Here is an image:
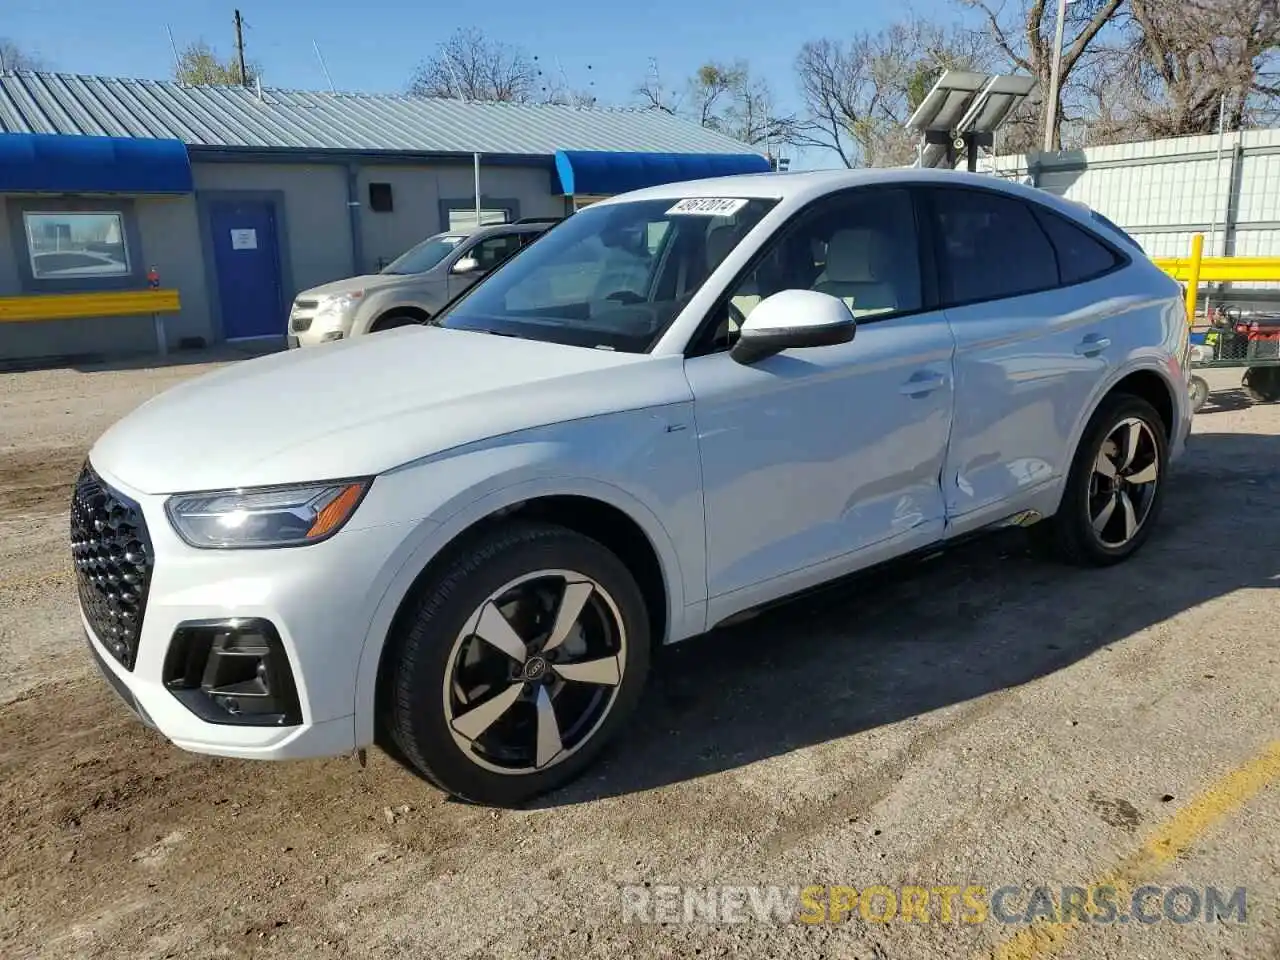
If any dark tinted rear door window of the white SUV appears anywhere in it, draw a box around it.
[933,189,1059,303]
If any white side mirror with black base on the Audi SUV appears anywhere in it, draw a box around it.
[730,291,858,364]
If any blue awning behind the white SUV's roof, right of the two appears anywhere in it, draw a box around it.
[556,150,771,197]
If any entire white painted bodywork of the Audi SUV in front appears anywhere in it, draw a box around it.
[74,170,1190,759]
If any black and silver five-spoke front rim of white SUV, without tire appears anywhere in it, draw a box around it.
[443,570,627,774]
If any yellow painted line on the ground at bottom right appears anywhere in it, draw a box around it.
[979,740,1280,960]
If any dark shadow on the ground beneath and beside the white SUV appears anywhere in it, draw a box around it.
[531,434,1280,808]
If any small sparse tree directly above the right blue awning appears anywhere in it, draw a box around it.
[636,60,796,146]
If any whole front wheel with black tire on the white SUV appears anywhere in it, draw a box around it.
[383,522,650,806]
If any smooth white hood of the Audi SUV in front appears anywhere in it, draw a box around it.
[90,326,689,494]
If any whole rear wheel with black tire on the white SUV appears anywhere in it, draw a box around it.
[1030,393,1169,567]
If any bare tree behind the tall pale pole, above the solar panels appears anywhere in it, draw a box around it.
[957,0,1126,150]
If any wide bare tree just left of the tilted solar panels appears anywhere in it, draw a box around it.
[794,17,987,166]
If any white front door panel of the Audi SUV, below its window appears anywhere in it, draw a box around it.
[685,305,952,617]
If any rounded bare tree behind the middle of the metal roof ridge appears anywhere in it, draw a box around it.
[410,27,539,104]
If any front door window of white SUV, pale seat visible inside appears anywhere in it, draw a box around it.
[708,188,923,349]
